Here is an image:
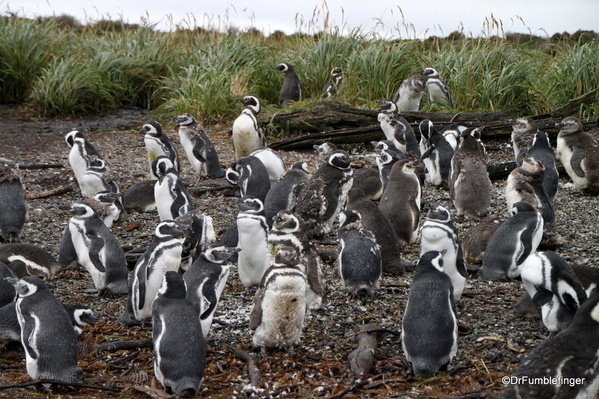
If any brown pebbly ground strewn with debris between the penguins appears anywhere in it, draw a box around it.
[0,107,599,398]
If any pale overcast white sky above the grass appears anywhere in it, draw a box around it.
[0,0,599,38]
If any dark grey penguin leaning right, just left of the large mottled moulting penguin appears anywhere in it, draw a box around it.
[264,161,310,227]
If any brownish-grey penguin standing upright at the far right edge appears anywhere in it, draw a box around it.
[556,116,599,194]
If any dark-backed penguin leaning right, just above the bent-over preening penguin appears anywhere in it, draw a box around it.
[478,201,543,280]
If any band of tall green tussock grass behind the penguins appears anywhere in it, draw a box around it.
[0,16,599,122]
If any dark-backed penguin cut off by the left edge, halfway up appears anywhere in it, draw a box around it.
[0,159,29,242]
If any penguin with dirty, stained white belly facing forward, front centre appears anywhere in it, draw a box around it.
[250,247,306,354]
